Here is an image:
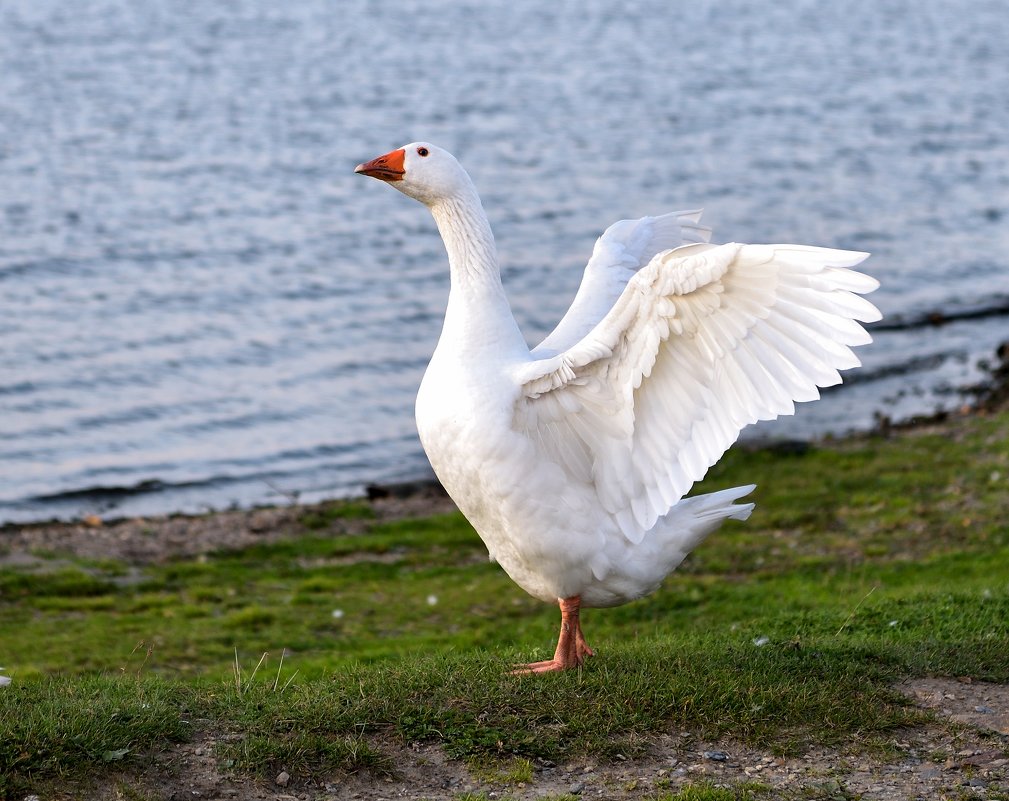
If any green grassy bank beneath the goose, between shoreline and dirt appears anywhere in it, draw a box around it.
[0,414,1009,799]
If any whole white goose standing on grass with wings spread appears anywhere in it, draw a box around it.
[355,142,880,673]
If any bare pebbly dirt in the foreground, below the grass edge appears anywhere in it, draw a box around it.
[101,679,1009,801]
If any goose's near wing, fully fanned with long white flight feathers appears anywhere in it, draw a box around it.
[515,243,880,542]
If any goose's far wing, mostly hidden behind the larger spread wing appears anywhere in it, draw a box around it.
[533,210,711,359]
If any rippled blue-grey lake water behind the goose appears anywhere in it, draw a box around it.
[0,0,1009,521]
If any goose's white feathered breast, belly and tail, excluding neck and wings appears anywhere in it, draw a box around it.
[417,348,753,606]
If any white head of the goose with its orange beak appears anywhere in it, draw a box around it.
[354,142,472,206]
